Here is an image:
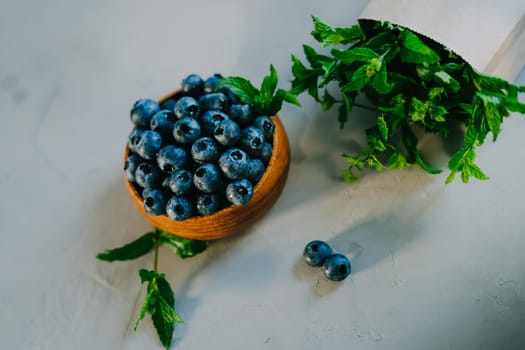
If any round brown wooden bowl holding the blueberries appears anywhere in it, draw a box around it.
[124,90,290,240]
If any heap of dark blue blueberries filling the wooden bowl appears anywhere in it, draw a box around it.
[124,74,275,221]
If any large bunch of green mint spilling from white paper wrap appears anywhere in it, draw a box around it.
[291,17,525,183]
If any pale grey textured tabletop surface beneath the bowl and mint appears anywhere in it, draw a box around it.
[0,0,525,350]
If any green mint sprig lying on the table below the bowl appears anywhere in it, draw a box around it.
[97,228,208,349]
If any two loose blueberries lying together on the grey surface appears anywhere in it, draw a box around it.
[303,240,352,281]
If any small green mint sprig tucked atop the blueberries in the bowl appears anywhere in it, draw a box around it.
[216,65,301,116]
